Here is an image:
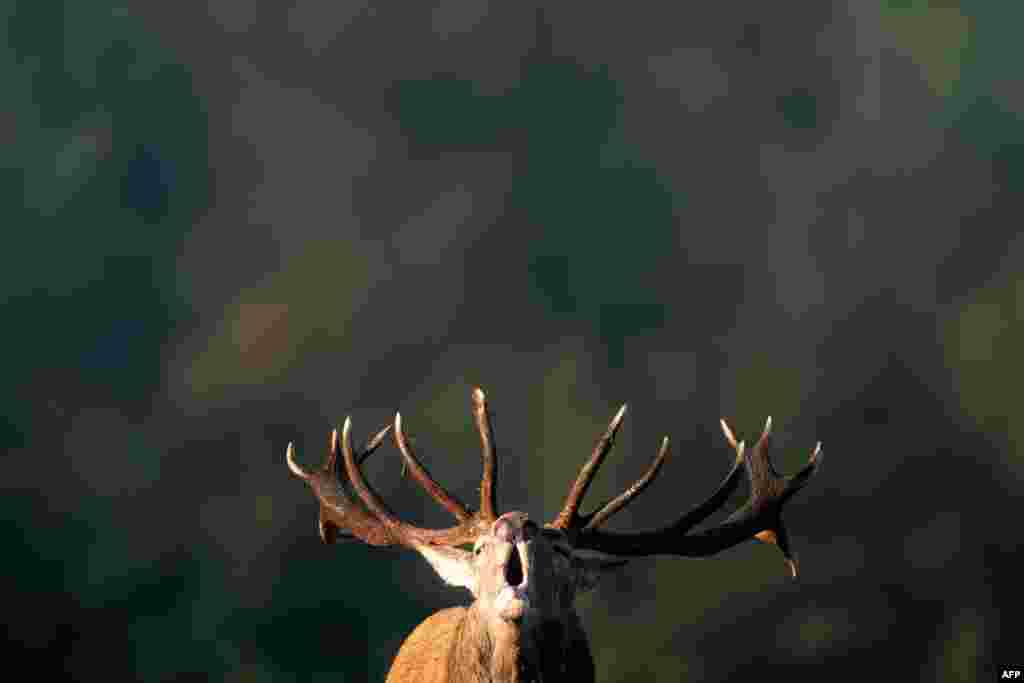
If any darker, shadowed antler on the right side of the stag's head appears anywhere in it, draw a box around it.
[550,405,821,578]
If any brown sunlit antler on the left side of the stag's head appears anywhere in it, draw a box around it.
[287,388,498,547]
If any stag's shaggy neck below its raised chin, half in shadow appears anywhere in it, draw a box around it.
[450,607,594,683]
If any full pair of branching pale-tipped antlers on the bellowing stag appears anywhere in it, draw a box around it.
[287,388,821,577]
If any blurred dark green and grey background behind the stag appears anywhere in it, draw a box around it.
[0,0,1024,681]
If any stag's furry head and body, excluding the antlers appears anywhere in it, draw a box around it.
[387,512,601,683]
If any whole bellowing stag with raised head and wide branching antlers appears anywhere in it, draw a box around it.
[287,388,821,683]
